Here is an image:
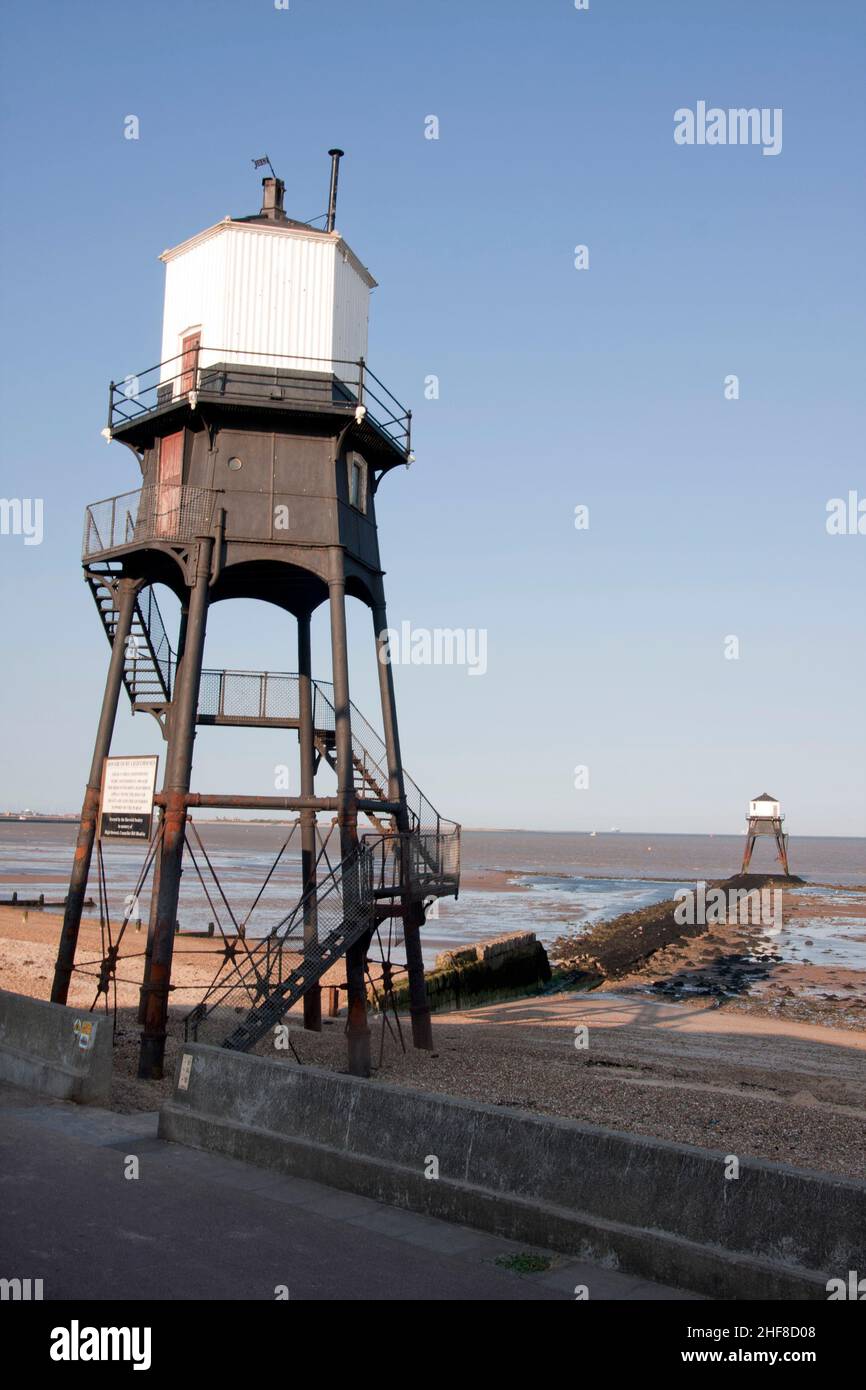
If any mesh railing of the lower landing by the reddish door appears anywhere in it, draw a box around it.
[82,484,215,560]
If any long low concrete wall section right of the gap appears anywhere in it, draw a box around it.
[160,1044,866,1300]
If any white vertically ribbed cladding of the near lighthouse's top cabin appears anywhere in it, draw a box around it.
[163,224,370,375]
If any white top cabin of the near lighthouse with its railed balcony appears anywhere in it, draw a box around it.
[106,173,411,468]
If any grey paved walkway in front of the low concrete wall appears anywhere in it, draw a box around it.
[0,1086,691,1301]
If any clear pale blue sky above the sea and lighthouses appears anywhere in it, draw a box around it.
[0,0,866,834]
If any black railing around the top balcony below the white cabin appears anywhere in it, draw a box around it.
[108,345,411,456]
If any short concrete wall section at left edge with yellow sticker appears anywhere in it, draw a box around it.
[0,990,113,1105]
